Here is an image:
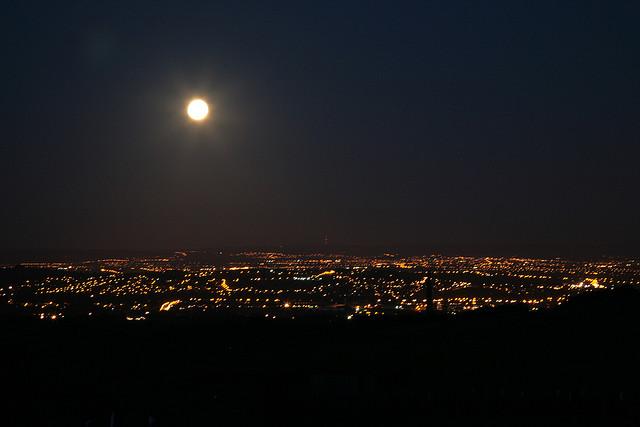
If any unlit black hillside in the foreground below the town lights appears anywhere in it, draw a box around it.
[0,290,640,426]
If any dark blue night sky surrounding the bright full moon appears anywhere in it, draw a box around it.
[0,0,640,256]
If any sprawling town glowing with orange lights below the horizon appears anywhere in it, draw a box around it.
[0,252,640,321]
